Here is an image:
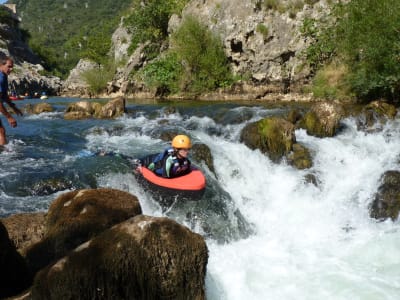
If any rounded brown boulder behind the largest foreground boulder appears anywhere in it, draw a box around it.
[26,188,142,272]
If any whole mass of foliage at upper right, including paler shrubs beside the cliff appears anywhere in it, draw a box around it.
[303,0,400,100]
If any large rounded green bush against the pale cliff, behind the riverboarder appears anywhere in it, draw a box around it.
[142,16,233,94]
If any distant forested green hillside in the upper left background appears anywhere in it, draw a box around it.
[8,0,132,77]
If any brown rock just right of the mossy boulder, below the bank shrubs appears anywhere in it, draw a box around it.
[299,102,345,138]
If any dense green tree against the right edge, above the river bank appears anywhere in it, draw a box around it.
[336,0,400,100]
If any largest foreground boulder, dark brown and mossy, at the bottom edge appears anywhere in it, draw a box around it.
[32,215,208,300]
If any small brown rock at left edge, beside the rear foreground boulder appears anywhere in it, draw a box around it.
[0,212,46,255]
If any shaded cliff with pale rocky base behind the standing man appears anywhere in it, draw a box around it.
[0,8,61,95]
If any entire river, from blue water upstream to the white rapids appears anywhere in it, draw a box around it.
[0,98,400,300]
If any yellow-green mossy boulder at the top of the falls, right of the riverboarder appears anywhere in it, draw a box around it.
[240,117,296,162]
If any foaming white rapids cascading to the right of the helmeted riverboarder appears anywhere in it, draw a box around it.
[203,120,400,300]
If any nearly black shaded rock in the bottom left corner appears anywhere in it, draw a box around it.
[0,222,32,299]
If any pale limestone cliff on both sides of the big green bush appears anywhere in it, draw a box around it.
[65,0,336,98]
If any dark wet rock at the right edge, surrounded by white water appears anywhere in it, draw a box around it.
[370,171,400,221]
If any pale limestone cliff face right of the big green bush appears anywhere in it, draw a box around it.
[180,0,329,92]
